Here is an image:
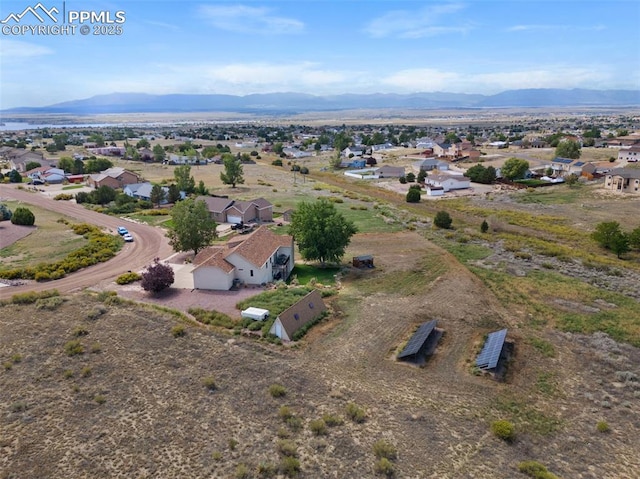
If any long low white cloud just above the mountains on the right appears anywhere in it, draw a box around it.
[381,66,613,94]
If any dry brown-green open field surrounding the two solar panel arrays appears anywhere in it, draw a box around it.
[0,148,640,479]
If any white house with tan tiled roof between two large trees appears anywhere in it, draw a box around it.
[192,226,294,290]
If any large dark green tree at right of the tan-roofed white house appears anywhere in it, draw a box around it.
[289,198,357,264]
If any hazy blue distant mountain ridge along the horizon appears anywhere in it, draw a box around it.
[1,88,640,115]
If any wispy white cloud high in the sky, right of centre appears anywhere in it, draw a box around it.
[364,3,471,38]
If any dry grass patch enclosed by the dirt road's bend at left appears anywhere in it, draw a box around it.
[0,201,88,270]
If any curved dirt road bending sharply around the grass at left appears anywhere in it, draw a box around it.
[0,185,173,299]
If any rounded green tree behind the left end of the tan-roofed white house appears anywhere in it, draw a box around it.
[167,198,217,255]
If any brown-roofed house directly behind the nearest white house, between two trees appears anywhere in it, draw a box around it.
[198,196,273,224]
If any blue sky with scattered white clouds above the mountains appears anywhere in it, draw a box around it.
[0,0,640,109]
